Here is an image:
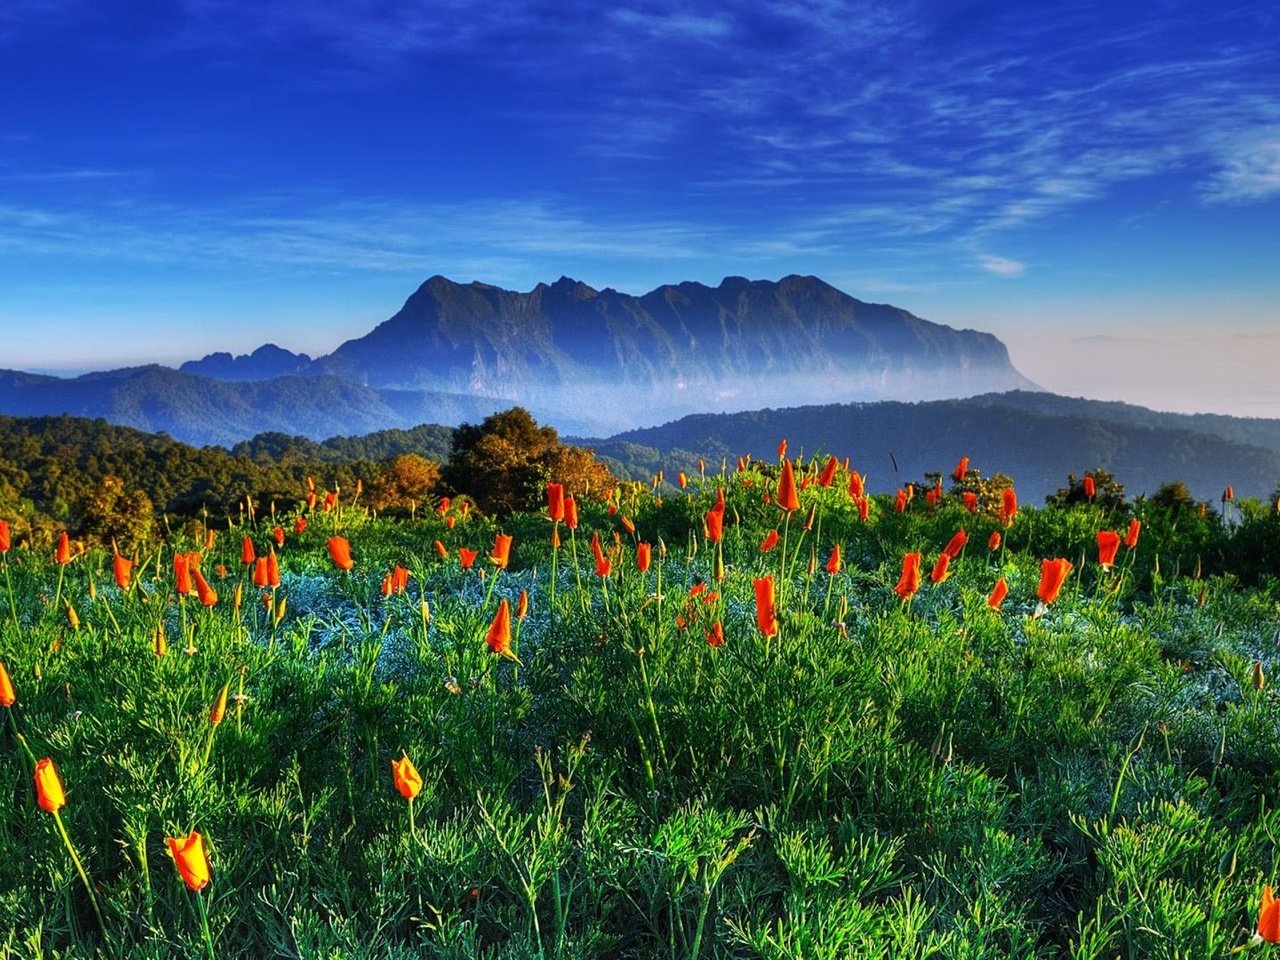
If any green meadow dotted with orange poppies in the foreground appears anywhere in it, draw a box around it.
[0,456,1280,960]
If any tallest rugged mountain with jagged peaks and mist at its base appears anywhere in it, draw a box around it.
[314,276,1036,430]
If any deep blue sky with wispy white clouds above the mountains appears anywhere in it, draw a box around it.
[0,0,1280,416]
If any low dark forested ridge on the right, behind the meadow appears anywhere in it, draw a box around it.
[583,393,1280,500]
